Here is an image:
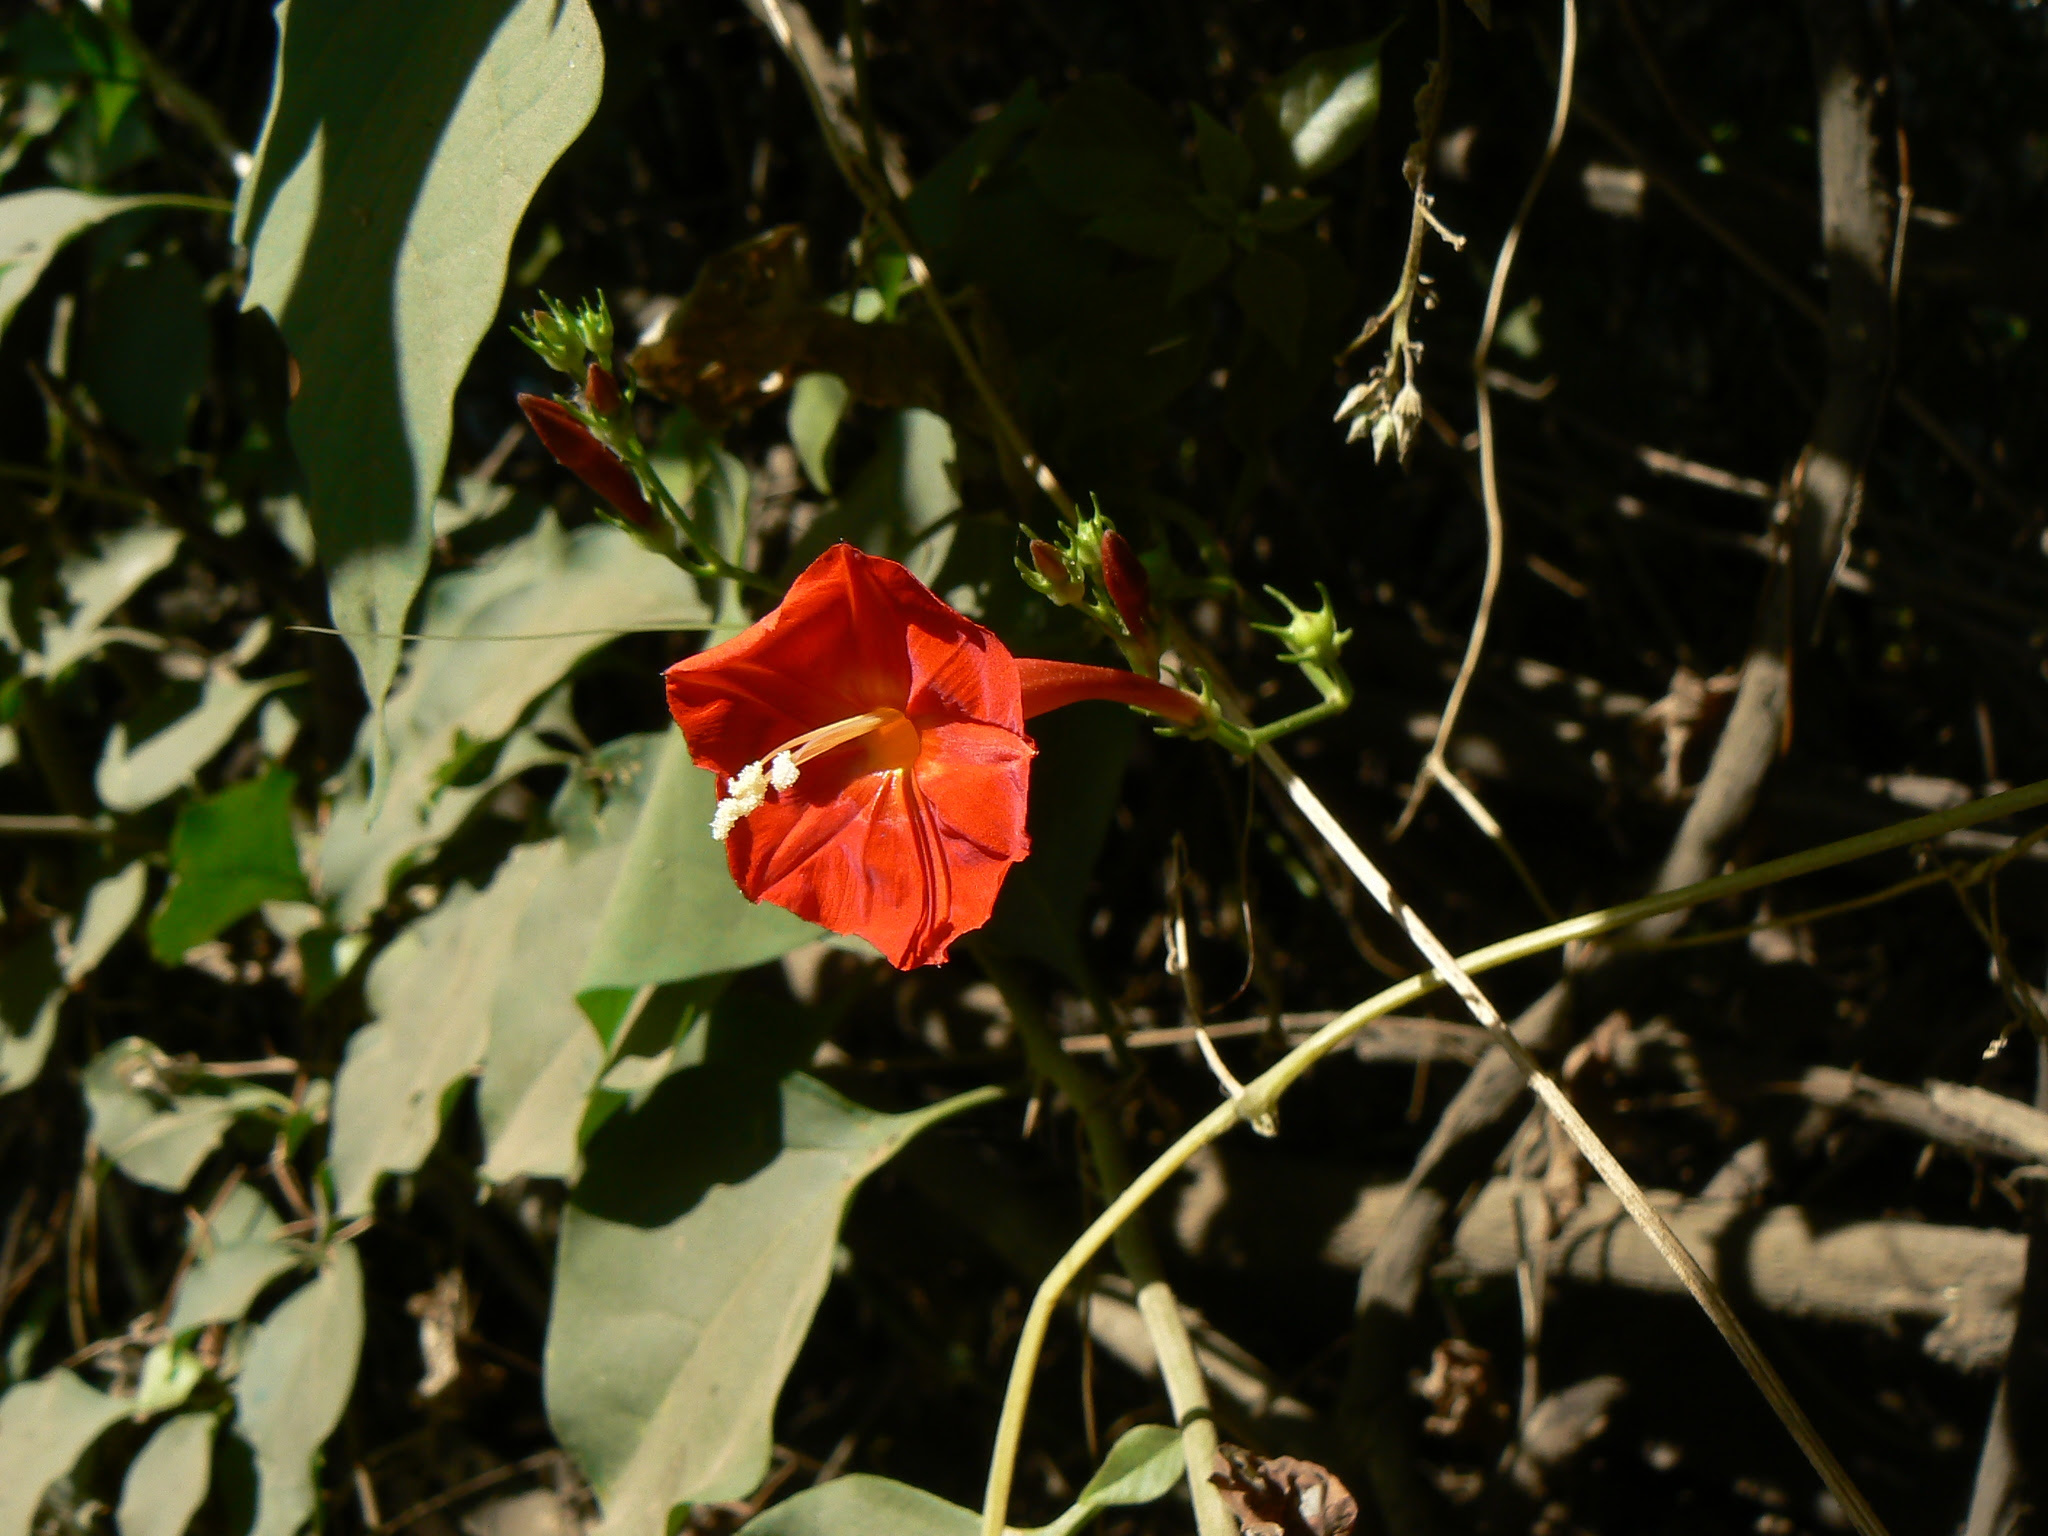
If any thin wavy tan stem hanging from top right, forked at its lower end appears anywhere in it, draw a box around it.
[1389,0,1579,856]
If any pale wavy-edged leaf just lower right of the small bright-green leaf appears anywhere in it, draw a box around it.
[328,858,567,1217]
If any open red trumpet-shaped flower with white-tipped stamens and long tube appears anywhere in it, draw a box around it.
[666,545,1202,969]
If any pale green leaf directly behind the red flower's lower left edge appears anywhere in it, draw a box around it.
[575,731,823,1020]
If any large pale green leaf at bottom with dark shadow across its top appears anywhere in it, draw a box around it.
[545,1073,989,1532]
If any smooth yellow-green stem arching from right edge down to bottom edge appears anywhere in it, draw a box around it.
[981,764,2048,1536]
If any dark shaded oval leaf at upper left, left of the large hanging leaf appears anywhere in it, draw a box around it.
[74,256,213,459]
